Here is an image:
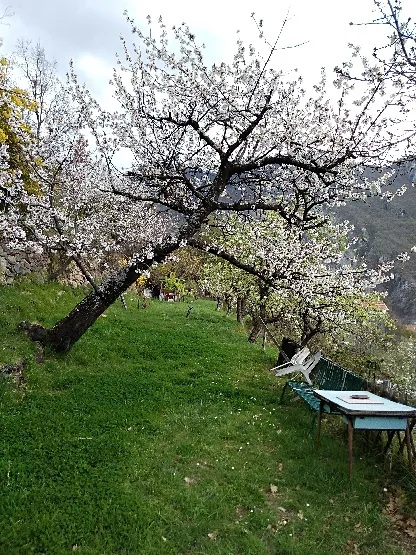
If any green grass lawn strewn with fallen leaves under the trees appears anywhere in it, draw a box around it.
[0,282,410,555]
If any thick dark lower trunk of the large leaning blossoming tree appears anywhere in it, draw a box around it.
[20,242,179,352]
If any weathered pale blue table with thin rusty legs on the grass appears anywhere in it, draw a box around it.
[313,389,416,478]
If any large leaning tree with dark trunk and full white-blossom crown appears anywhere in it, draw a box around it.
[4,17,412,351]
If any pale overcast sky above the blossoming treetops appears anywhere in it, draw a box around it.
[0,0,402,88]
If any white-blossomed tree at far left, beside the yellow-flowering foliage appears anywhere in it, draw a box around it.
[3,43,173,291]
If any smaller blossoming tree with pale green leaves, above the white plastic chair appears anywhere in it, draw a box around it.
[198,213,391,346]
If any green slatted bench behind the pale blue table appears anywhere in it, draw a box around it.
[280,356,367,433]
